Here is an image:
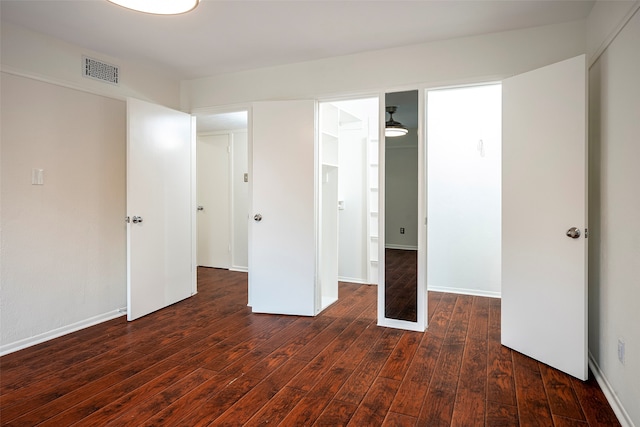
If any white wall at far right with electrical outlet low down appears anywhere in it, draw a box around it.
[589,3,640,426]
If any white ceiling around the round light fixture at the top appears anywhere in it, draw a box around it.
[0,0,594,79]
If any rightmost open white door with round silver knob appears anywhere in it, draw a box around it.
[502,55,587,380]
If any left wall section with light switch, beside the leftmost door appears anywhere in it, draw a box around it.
[0,73,126,353]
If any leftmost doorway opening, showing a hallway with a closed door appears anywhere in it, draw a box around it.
[196,111,249,271]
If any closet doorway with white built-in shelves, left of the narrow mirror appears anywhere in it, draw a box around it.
[319,97,379,290]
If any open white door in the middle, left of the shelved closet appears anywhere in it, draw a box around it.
[249,100,316,315]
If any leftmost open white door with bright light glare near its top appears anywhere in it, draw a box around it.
[127,99,196,320]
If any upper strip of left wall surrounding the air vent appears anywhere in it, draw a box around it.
[0,22,180,109]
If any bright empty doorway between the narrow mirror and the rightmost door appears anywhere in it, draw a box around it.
[426,84,502,297]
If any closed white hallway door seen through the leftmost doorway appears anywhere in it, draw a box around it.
[196,134,231,268]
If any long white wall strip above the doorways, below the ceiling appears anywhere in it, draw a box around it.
[182,21,585,111]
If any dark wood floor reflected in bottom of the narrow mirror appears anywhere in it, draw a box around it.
[384,249,418,322]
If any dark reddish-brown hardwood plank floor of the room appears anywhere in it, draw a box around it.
[0,269,619,427]
